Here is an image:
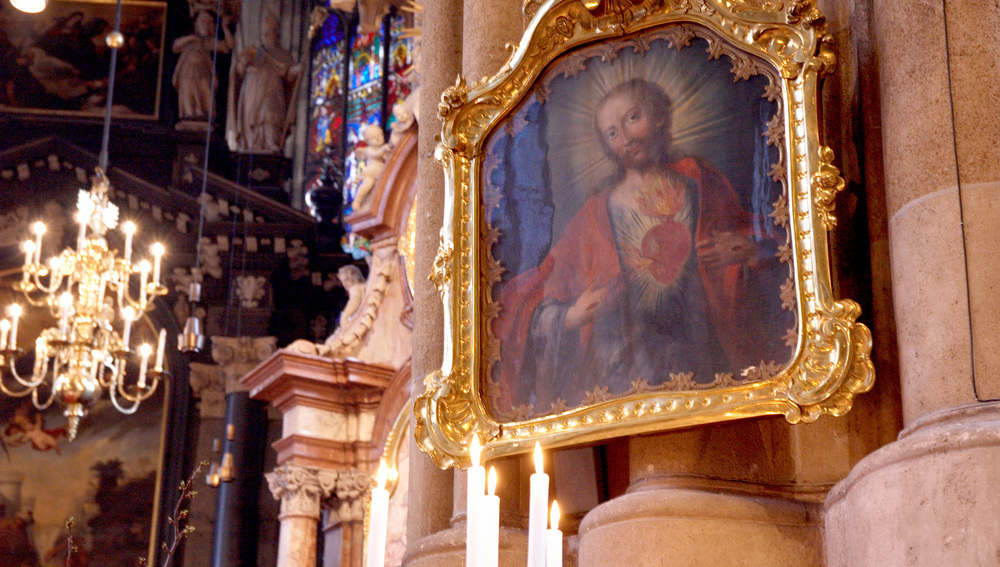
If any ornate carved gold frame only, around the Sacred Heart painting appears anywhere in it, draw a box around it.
[414,0,874,468]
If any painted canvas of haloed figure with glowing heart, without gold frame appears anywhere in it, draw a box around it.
[484,27,795,419]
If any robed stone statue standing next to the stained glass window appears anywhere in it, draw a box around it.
[226,13,302,154]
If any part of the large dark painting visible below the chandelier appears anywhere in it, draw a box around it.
[0,386,166,567]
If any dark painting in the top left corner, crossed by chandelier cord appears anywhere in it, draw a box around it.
[0,0,167,120]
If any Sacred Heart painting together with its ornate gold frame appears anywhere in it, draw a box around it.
[414,0,874,466]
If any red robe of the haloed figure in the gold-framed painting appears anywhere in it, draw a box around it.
[493,158,757,414]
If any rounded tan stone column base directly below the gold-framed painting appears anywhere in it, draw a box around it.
[579,488,823,567]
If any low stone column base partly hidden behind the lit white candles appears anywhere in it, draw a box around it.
[403,522,528,567]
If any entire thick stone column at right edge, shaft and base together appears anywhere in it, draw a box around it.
[825,0,1000,567]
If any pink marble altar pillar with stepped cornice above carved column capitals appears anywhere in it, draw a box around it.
[241,350,396,567]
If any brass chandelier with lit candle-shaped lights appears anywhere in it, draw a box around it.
[0,168,167,441]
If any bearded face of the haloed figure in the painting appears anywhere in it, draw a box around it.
[597,90,665,170]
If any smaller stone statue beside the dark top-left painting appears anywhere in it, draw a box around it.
[173,10,233,121]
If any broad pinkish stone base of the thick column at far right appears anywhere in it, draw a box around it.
[825,404,1000,567]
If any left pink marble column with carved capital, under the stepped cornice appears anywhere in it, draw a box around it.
[265,463,337,567]
